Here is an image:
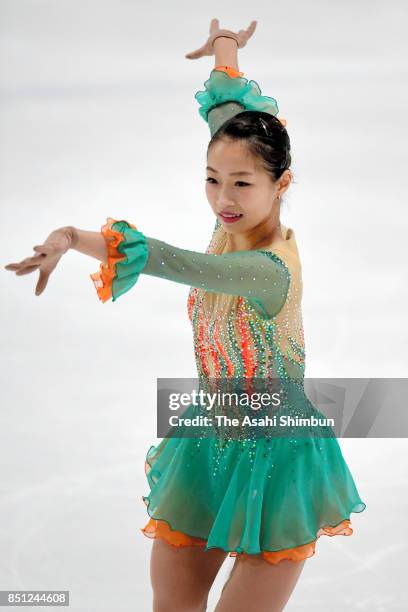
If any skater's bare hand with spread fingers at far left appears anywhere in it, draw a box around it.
[4,227,75,295]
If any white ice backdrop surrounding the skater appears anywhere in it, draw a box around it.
[0,0,408,612]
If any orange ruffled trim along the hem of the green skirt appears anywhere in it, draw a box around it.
[140,517,353,565]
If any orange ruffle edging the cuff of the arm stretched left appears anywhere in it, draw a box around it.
[90,217,137,302]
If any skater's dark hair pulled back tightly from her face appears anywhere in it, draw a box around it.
[207,110,292,181]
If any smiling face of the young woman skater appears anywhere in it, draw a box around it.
[205,138,290,233]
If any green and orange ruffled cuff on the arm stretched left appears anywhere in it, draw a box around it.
[90,217,149,302]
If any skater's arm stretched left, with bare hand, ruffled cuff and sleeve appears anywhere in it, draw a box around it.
[5,217,291,318]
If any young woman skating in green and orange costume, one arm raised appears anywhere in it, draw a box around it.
[6,19,365,612]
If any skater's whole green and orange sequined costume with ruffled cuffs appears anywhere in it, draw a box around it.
[91,66,366,564]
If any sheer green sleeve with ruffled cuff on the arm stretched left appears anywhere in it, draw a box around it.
[91,217,291,318]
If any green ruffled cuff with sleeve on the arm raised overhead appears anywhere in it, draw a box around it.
[194,66,286,136]
